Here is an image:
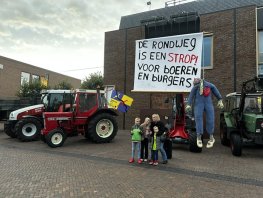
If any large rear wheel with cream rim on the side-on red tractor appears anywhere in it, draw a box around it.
[85,113,118,143]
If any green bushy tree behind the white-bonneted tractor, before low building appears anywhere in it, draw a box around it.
[16,81,48,97]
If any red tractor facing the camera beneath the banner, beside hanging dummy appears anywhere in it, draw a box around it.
[164,93,202,159]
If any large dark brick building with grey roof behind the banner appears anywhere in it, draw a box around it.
[104,0,263,129]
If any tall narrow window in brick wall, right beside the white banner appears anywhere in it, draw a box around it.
[202,35,213,69]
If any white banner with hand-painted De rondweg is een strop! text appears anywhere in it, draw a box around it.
[133,33,203,92]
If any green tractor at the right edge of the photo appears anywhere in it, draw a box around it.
[220,77,263,156]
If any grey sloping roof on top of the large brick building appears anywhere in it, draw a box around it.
[119,0,263,29]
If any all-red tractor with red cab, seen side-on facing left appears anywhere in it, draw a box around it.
[41,90,118,148]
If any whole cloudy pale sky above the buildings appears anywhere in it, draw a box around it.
[0,0,172,80]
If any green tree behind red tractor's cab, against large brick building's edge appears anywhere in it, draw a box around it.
[80,72,104,89]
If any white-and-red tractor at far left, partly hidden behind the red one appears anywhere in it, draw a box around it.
[4,90,71,141]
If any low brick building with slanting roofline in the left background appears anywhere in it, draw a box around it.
[0,56,81,99]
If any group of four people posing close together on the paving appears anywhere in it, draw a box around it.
[129,114,168,166]
